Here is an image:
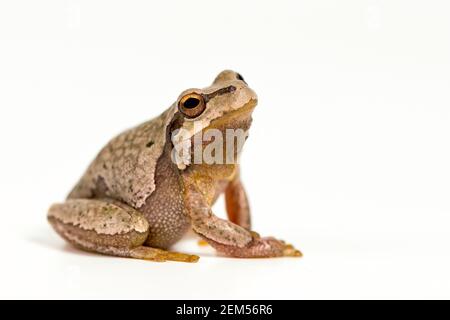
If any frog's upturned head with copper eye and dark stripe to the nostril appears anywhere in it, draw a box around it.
[171,70,257,169]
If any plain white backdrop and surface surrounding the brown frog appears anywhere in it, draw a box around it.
[0,0,450,299]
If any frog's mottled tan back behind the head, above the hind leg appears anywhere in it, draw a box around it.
[68,107,174,208]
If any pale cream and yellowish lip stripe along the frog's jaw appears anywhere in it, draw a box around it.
[171,99,258,170]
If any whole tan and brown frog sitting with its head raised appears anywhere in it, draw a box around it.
[47,70,302,262]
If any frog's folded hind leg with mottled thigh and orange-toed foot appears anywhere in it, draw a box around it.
[48,199,198,262]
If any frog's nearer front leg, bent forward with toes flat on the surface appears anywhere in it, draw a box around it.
[185,184,301,258]
